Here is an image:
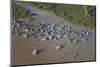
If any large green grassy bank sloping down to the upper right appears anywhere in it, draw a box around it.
[24,2,96,28]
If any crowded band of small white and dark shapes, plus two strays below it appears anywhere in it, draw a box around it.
[11,20,90,55]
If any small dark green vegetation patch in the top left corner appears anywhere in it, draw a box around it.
[12,3,28,19]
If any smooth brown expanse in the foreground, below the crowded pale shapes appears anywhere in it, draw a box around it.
[11,31,95,65]
